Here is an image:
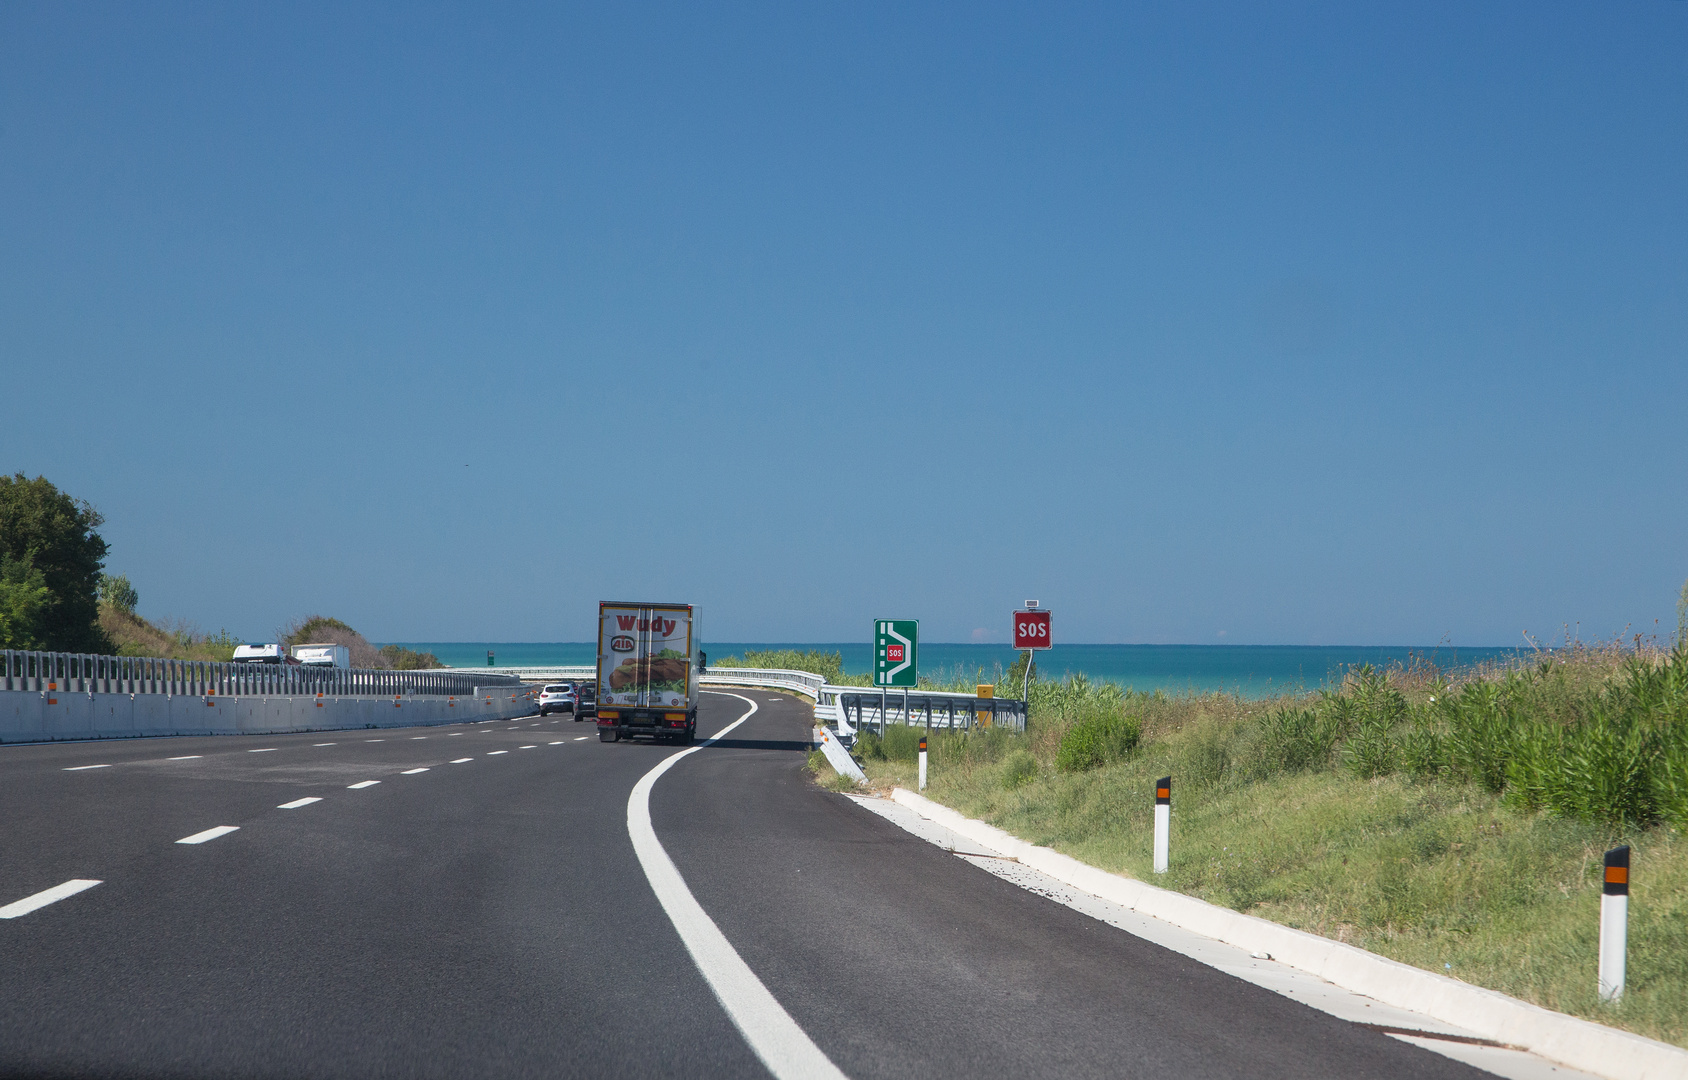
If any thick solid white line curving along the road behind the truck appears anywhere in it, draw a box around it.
[628,690,844,1080]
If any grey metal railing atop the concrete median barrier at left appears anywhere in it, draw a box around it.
[0,650,522,697]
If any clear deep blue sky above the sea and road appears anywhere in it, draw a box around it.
[0,0,1688,645]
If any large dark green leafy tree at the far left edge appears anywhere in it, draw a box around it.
[0,473,111,653]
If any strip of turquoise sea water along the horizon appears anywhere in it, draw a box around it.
[397,641,1518,697]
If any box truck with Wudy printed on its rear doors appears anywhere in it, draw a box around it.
[598,601,704,743]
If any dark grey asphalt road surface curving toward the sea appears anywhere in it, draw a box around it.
[0,690,1505,1080]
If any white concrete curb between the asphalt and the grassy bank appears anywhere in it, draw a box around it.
[891,788,1688,1080]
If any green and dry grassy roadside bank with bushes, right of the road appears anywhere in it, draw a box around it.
[850,637,1688,1046]
